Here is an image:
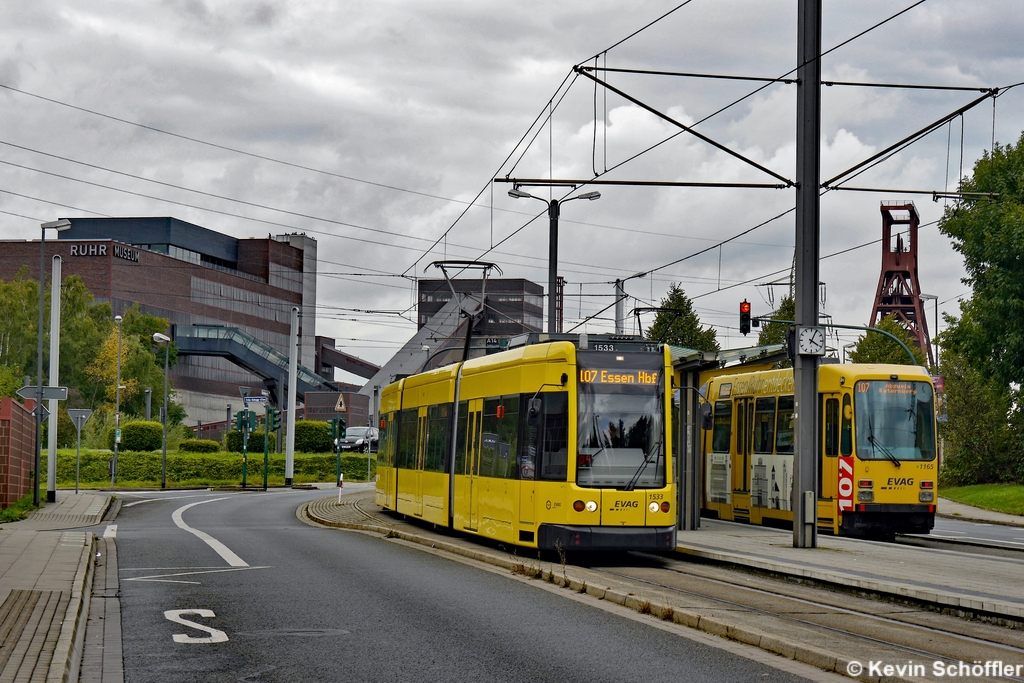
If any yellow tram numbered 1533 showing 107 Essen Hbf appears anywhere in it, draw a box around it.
[376,341,676,551]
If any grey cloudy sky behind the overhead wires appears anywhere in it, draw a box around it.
[0,0,1024,382]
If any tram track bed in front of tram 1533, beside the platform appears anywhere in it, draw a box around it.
[587,559,1024,681]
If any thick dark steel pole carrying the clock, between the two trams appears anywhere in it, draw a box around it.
[793,0,821,548]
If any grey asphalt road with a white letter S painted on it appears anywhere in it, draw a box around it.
[110,490,817,683]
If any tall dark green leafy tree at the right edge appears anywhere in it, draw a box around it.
[939,133,1024,395]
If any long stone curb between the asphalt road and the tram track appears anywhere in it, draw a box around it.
[295,501,914,683]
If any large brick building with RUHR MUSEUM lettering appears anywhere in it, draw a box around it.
[0,217,316,424]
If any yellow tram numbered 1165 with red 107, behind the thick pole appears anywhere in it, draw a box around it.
[702,365,938,538]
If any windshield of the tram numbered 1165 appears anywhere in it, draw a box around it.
[854,380,935,466]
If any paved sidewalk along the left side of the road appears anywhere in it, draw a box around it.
[0,490,111,683]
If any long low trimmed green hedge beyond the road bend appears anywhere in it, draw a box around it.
[40,450,376,487]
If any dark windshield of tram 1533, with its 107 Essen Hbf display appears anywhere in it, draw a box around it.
[577,352,667,489]
